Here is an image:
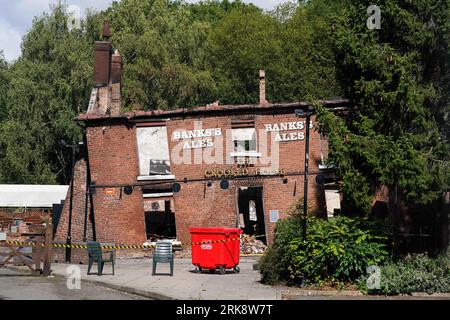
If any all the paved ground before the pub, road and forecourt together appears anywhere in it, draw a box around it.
[4,257,450,300]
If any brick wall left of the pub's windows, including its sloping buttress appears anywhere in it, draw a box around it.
[55,125,146,248]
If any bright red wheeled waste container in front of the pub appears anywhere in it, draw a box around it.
[189,228,242,274]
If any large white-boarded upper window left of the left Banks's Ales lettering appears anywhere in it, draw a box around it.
[136,126,171,176]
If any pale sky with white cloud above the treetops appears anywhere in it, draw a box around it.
[0,0,284,62]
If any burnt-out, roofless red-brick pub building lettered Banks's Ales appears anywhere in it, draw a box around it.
[55,25,348,252]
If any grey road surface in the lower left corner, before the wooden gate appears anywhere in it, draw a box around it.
[0,268,149,300]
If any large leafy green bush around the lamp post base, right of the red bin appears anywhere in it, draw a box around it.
[258,215,388,285]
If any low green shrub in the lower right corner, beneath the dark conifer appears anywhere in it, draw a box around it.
[359,254,450,295]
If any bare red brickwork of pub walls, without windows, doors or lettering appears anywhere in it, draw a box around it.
[57,110,324,244]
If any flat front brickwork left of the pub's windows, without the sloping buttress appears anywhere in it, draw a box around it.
[87,124,146,243]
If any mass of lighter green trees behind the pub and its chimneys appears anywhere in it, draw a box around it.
[0,0,384,183]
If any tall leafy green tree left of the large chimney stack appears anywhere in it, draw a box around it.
[0,4,92,183]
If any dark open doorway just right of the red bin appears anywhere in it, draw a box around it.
[238,187,267,244]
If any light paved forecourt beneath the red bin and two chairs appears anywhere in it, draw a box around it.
[47,257,282,300]
